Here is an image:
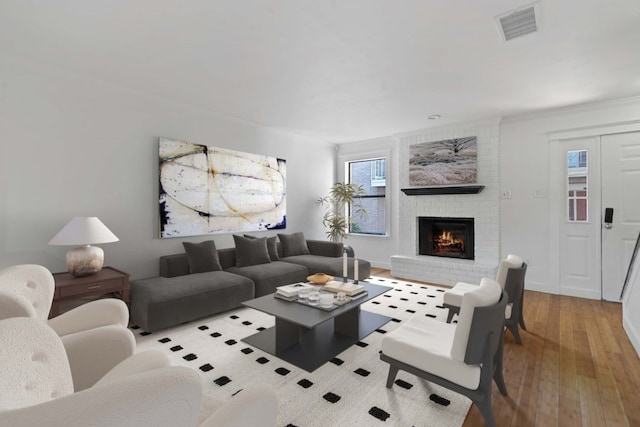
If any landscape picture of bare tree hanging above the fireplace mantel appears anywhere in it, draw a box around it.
[409,136,478,187]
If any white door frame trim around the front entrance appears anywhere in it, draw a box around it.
[547,120,640,299]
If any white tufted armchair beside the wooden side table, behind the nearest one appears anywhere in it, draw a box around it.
[0,264,135,390]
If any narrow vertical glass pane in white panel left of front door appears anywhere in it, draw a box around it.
[567,150,589,222]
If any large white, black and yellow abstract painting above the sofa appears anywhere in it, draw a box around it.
[159,138,286,238]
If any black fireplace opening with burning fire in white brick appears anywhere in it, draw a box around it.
[418,216,475,259]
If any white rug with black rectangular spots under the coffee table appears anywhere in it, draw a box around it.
[131,276,471,427]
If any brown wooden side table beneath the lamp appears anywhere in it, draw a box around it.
[49,267,130,318]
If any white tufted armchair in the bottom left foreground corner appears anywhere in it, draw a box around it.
[0,317,278,427]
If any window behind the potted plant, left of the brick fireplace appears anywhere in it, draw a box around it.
[345,158,387,236]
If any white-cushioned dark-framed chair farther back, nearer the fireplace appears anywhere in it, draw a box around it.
[442,254,527,344]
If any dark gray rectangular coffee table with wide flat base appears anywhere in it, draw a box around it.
[242,282,393,372]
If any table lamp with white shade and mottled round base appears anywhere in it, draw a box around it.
[49,216,119,277]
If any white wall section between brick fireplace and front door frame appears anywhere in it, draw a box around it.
[500,98,640,293]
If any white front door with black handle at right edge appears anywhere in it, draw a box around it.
[601,132,640,301]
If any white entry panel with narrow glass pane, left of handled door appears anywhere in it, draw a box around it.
[554,137,601,299]
